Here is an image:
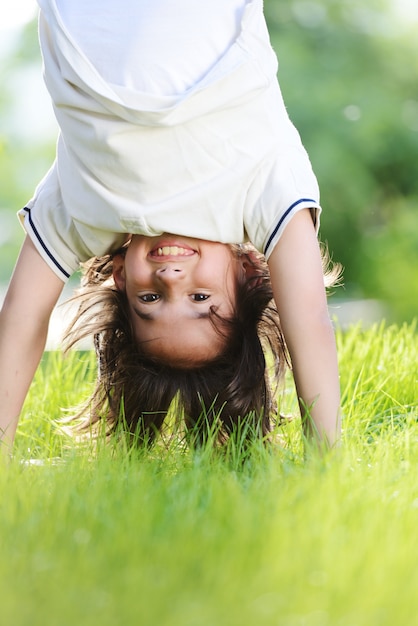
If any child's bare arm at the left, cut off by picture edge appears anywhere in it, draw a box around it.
[0,237,64,455]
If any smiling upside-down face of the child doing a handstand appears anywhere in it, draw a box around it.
[114,235,244,366]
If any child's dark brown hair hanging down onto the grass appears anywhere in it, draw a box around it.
[64,244,340,444]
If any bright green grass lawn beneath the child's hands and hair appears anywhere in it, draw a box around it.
[0,325,418,626]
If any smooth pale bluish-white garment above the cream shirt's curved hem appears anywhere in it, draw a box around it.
[56,0,247,95]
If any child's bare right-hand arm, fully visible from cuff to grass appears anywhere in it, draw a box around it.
[268,209,340,447]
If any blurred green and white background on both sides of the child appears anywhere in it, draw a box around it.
[0,0,418,321]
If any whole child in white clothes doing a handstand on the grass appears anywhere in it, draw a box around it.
[0,0,339,445]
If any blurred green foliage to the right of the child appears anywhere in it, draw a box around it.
[265,0,418,318]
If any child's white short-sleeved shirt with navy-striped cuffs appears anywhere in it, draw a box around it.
[19,0,320,280]
